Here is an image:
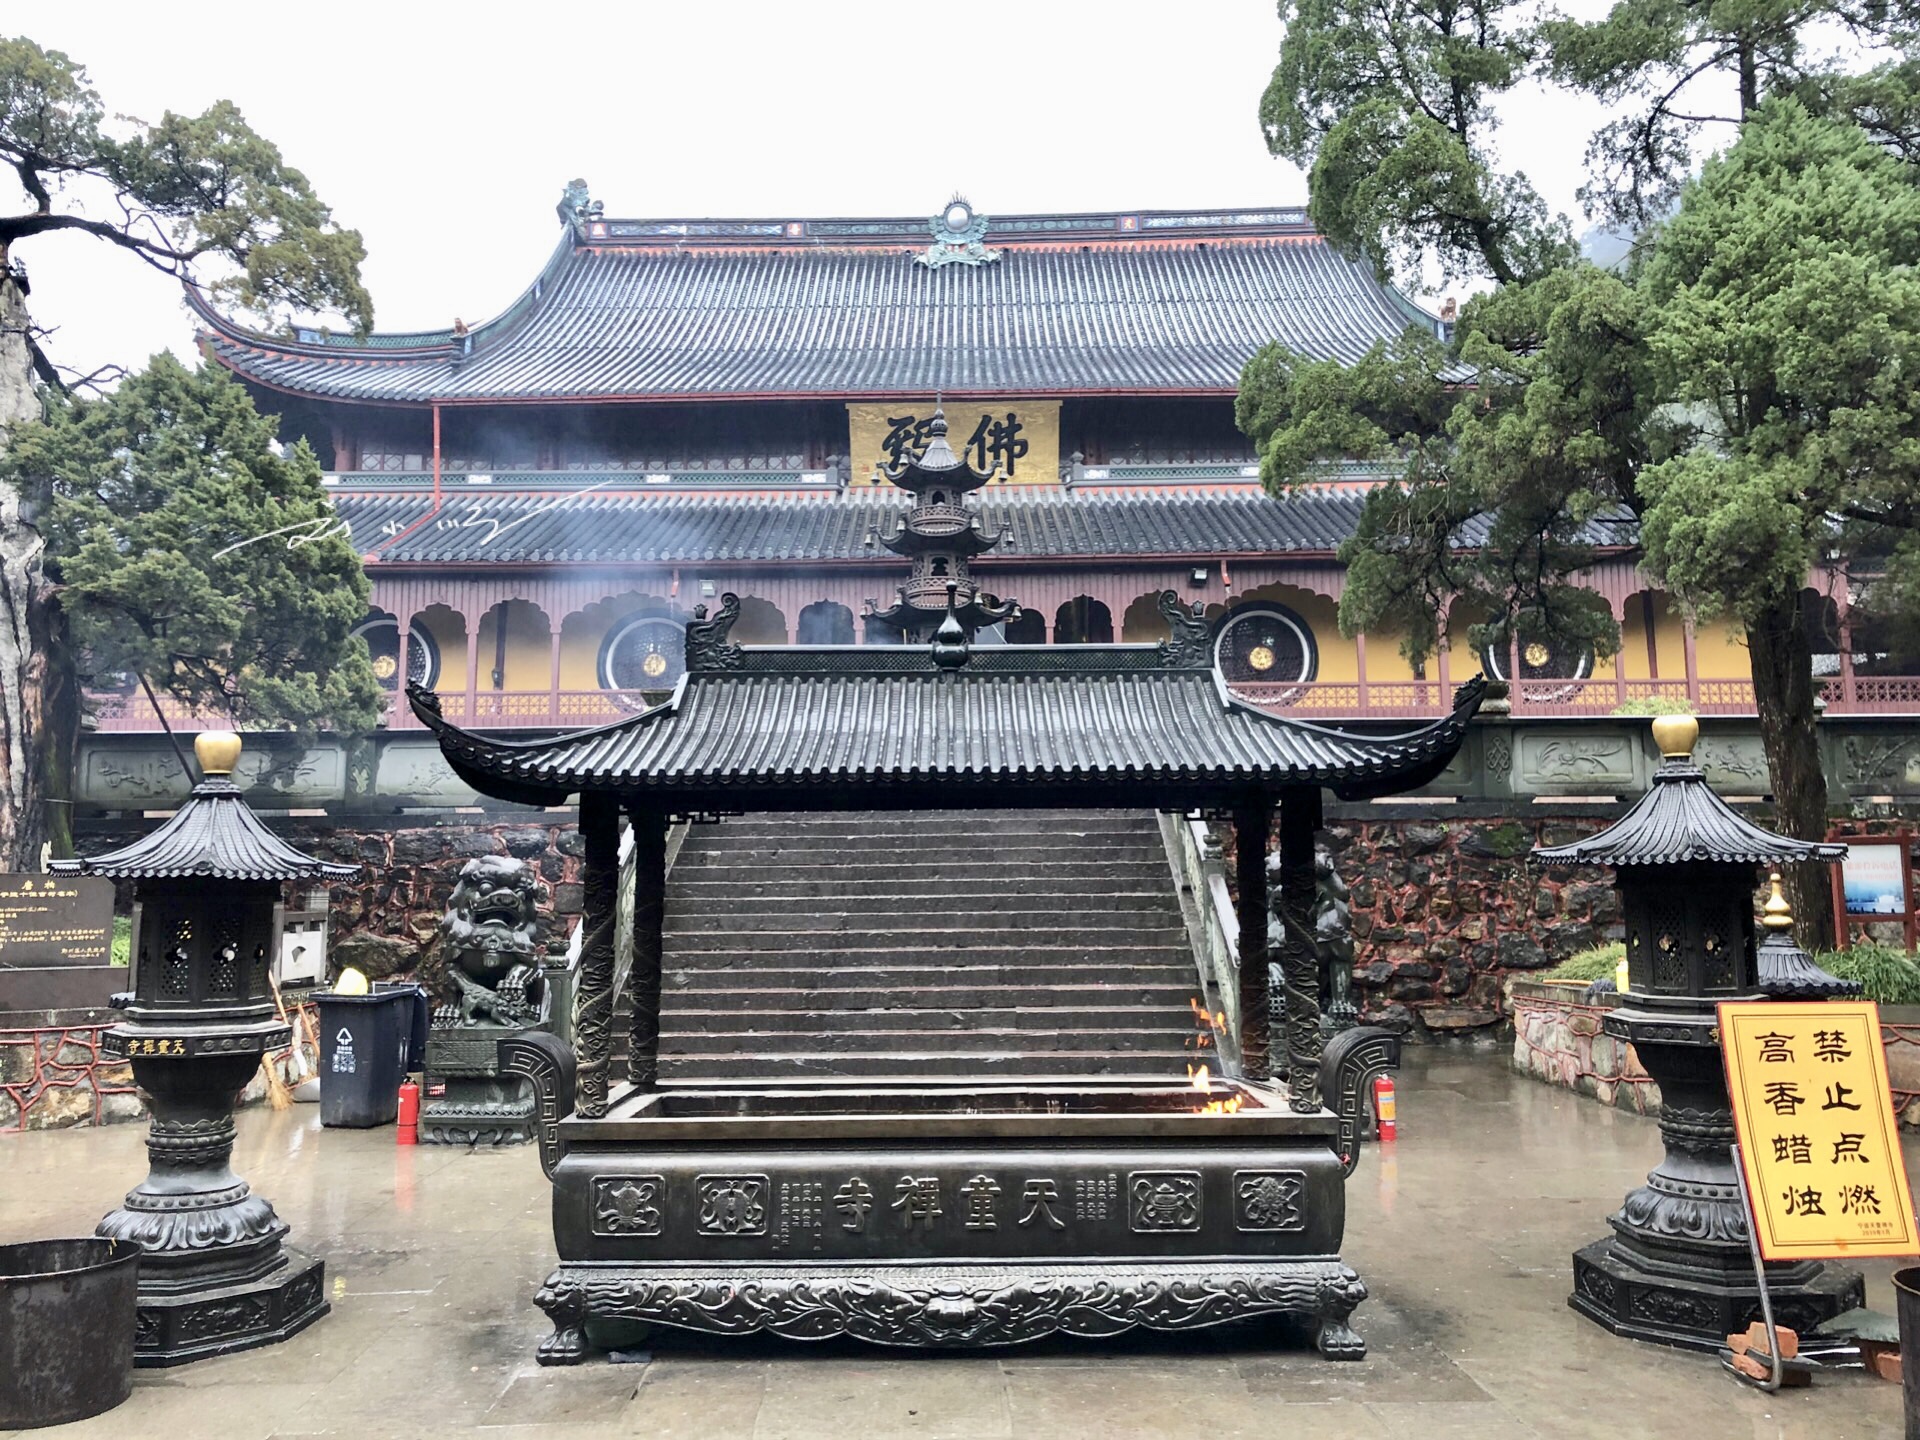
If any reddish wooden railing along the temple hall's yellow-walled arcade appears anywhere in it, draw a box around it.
[92,676,1920,733]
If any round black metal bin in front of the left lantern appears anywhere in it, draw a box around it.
[0,1240,140,1430]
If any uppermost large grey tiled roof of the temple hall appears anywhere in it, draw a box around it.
[202,215,1434,401]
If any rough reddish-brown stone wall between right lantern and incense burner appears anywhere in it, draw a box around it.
[1327,816,1620,1039]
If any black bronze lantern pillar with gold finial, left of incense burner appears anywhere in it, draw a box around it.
[52,732,357,1365]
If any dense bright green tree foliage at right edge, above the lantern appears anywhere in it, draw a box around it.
[1642,100,1920,626]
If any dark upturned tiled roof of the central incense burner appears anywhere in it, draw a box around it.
[407,645,1486,810]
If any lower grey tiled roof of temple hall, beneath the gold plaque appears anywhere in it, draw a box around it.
[334,486,1361,564]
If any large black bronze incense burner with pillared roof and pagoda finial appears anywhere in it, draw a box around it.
[409,439,1484,1363]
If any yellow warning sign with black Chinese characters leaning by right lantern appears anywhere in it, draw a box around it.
[1720,1000,1920,1260]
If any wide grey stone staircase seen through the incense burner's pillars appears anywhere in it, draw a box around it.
[616,810,1200,1083]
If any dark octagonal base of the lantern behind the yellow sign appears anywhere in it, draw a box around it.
[1567,1236,1866,1350]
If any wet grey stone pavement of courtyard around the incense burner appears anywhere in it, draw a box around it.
[0,1050,1901,1440]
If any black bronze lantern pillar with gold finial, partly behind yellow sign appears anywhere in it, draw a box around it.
[1532,716,1864,1350]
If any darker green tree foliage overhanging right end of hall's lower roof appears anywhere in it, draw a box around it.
[1235,265,1663,662]
